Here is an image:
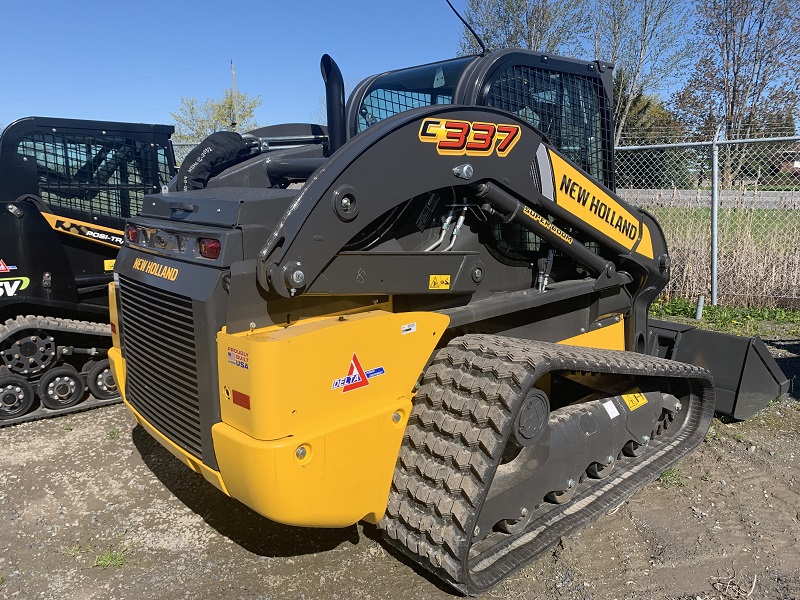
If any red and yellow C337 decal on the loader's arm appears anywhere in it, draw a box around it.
[419,119,522,156]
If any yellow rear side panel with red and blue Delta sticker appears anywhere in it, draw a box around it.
[212,310,449,527]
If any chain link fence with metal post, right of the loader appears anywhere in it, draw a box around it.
[615,137,800,308]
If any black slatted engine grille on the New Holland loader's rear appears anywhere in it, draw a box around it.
[120,277,202,458]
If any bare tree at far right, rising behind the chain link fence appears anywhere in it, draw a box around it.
[673,0,800,186]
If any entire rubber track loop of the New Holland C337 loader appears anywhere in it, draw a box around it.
[380,335,714,594]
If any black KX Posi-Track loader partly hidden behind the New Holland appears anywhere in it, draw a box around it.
[0,117,175,426]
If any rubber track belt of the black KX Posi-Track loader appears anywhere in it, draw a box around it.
[0,315,122,428]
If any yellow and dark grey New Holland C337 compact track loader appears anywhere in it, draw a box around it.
[109,50,787,594]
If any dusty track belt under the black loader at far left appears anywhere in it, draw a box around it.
[0,315,122,427]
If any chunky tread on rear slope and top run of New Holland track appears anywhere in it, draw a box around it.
[380,335,706,593]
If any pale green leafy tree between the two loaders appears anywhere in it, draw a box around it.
[170,89,263,143]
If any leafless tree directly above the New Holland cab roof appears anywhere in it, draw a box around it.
[459,0,590,55]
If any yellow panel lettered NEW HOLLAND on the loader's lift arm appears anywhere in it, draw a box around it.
[549,150,653,258]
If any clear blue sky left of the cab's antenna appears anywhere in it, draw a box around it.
[0,0,466,131]
